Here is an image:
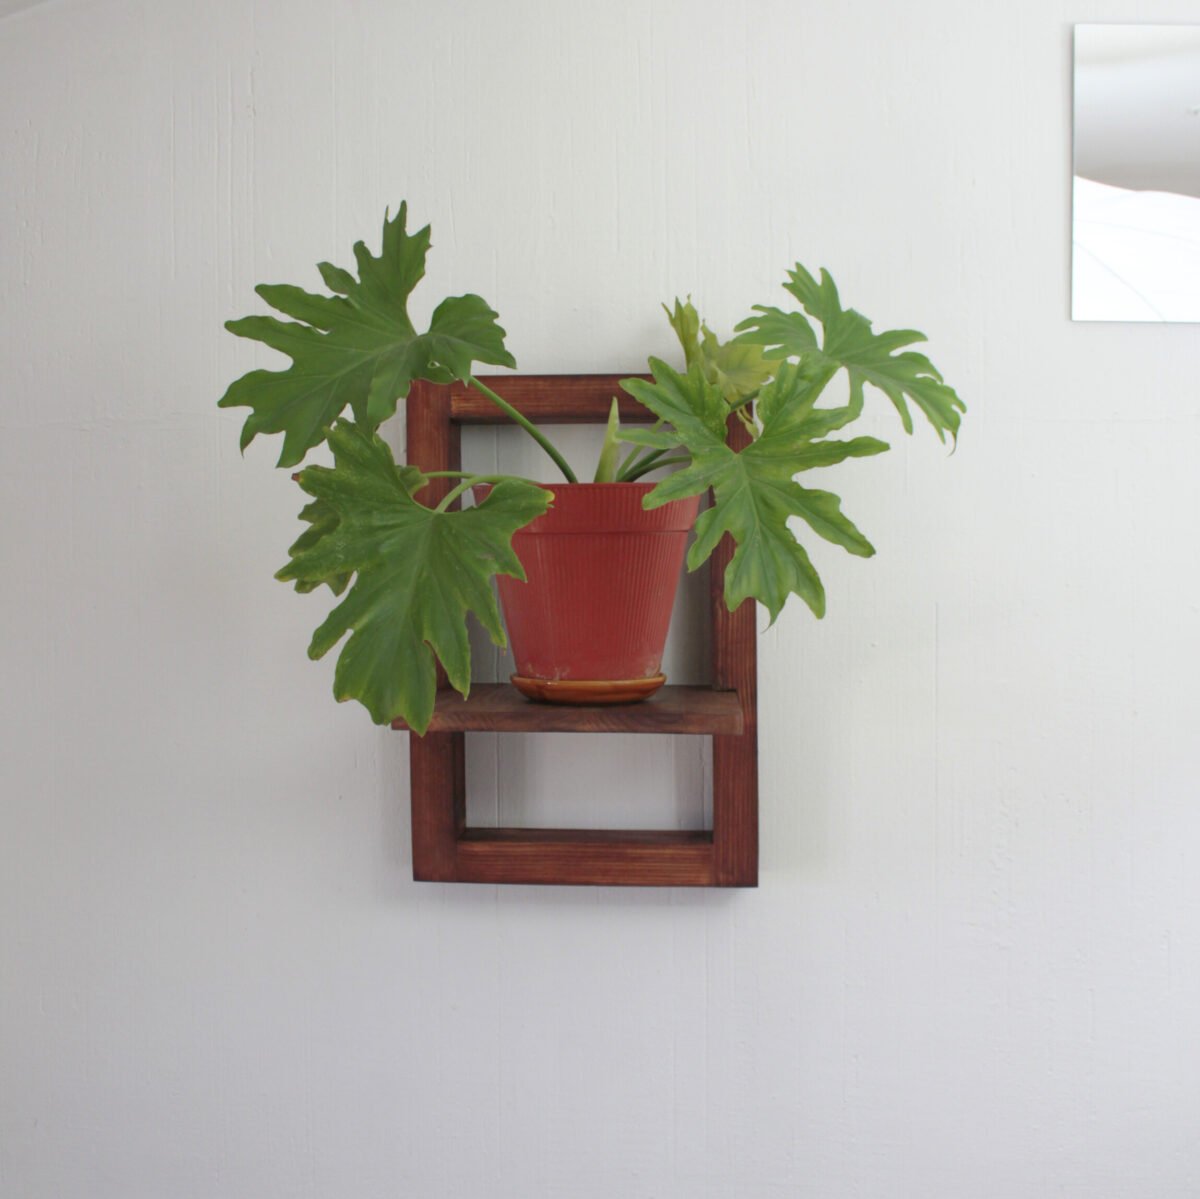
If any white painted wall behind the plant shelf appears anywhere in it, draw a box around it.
[0,0,1200,1199]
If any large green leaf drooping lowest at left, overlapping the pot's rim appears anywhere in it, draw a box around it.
[276,420,550,733]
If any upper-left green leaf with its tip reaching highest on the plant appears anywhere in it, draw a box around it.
[220,204,516,467]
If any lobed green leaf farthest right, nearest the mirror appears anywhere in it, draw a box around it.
[734,263,966,442]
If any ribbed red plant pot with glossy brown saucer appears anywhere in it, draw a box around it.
[475,482,700,703]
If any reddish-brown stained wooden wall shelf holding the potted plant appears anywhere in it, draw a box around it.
[403,374,758,887]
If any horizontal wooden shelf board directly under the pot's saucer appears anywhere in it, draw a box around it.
[392,683,744,735]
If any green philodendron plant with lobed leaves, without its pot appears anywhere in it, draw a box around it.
[220,204,965,732]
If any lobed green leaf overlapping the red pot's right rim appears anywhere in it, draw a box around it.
[622,360,888,622]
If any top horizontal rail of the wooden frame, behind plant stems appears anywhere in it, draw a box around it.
[446,373,654,425]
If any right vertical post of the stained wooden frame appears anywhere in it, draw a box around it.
[709,418,758,887]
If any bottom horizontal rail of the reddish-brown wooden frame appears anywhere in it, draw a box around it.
[456,828,713,887]
